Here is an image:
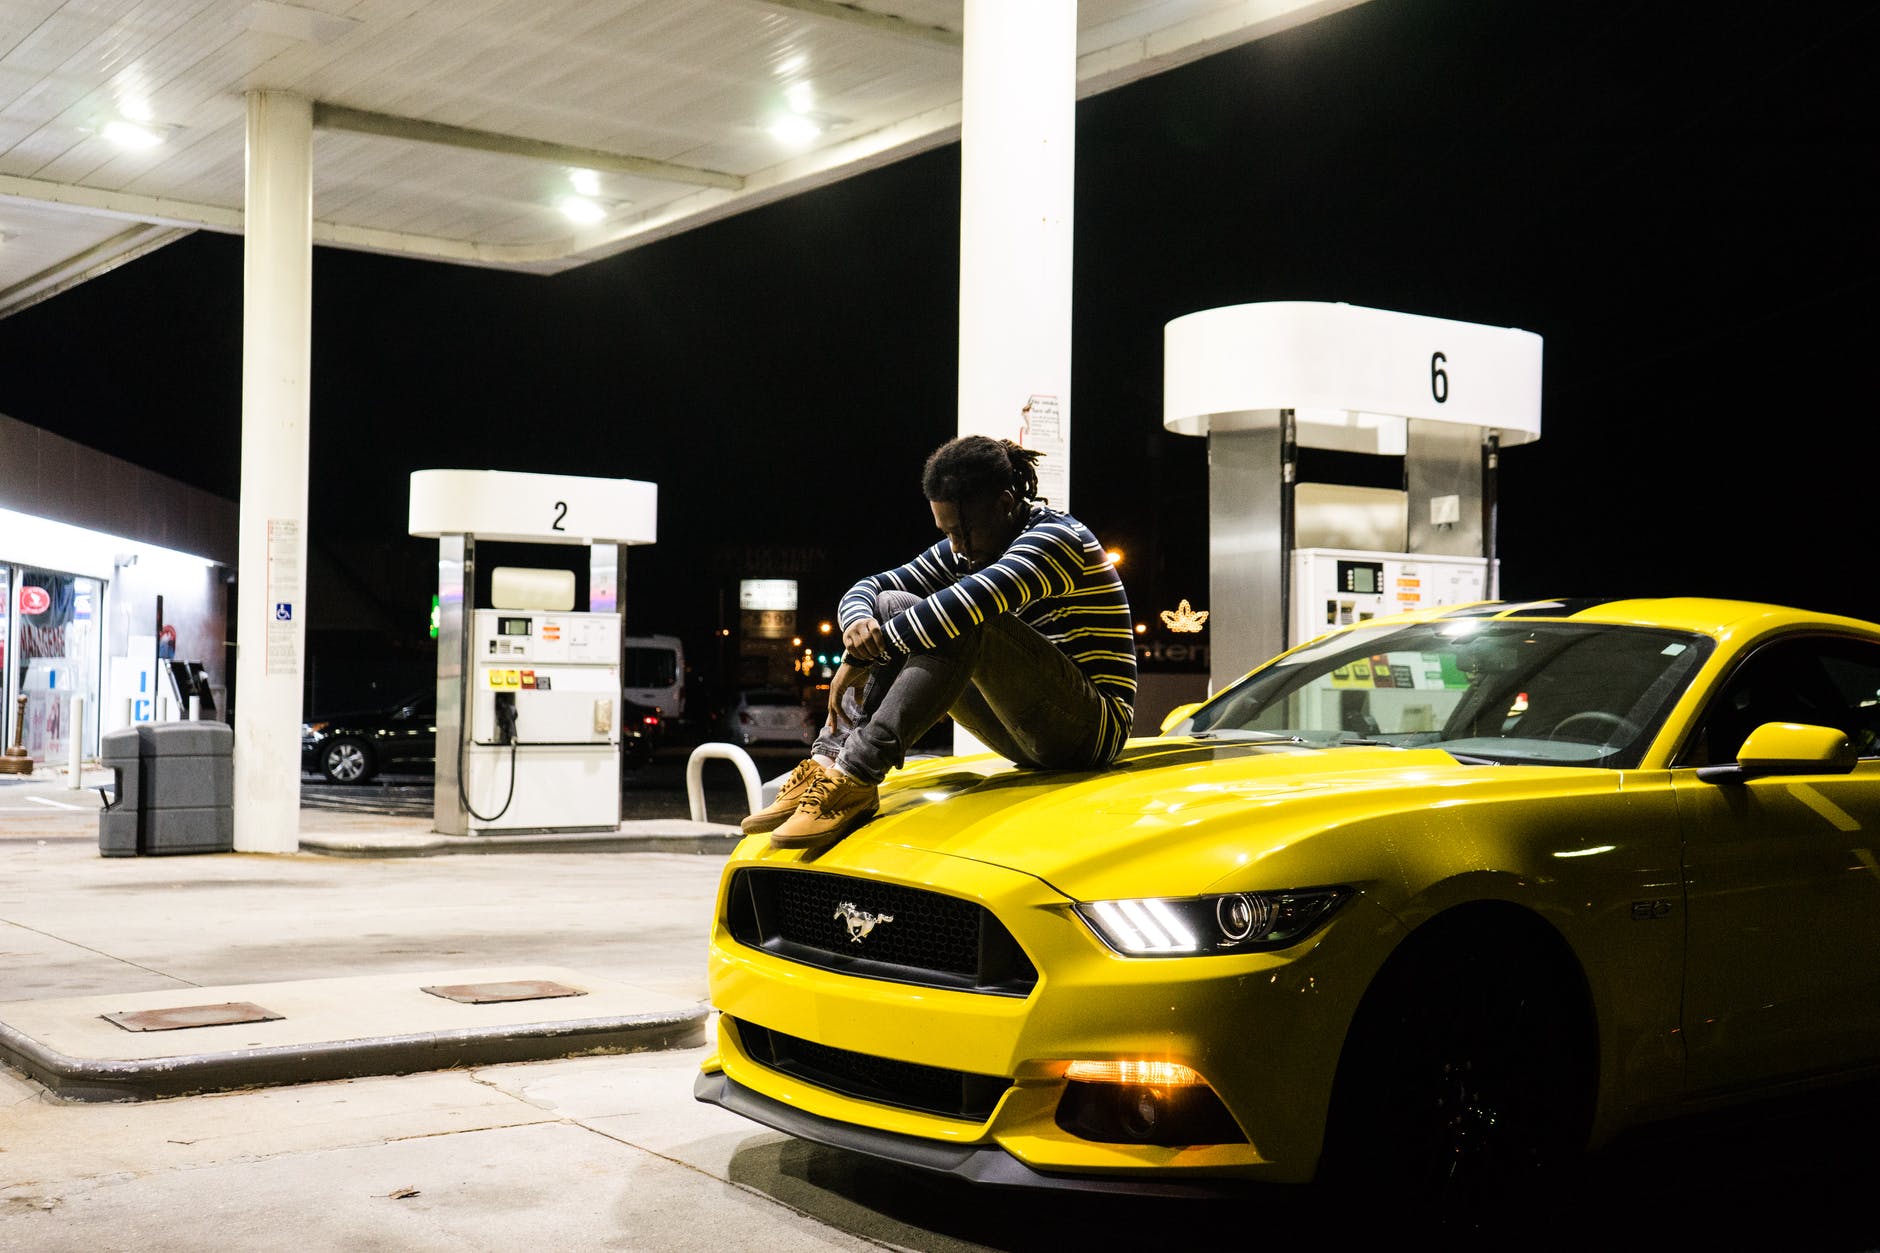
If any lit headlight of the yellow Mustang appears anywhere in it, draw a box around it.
[1075,888,1352,958]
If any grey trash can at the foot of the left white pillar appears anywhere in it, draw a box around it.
[98,722,235,858]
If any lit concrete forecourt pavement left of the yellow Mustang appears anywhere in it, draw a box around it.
[0,760,979,1253]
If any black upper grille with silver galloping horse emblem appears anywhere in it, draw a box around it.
[728,867,1038,997]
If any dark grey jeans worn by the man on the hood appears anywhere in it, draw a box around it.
[812,591,1107,783]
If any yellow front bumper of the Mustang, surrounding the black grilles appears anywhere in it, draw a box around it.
[699,845,1395,1191]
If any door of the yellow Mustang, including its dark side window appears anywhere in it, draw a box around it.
[1673,636,1880,1093]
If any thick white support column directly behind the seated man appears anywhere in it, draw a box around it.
[953,0,1077,753]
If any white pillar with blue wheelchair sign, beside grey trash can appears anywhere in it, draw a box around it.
[235,90,314,852]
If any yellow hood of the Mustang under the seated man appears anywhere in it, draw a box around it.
[785,738,1619,899]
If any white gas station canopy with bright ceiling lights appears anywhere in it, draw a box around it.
[0,0,1361,316]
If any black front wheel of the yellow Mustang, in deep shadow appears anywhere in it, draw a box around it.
[1320,920,1594,1229]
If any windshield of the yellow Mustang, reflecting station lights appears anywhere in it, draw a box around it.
[1171,619,1711,768]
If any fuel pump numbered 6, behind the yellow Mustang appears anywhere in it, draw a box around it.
[1162,301,1542,690]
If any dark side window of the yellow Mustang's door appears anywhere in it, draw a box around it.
[1675,636,1880,766]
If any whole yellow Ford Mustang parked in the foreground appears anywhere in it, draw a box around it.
[696,600,1880,1200]
